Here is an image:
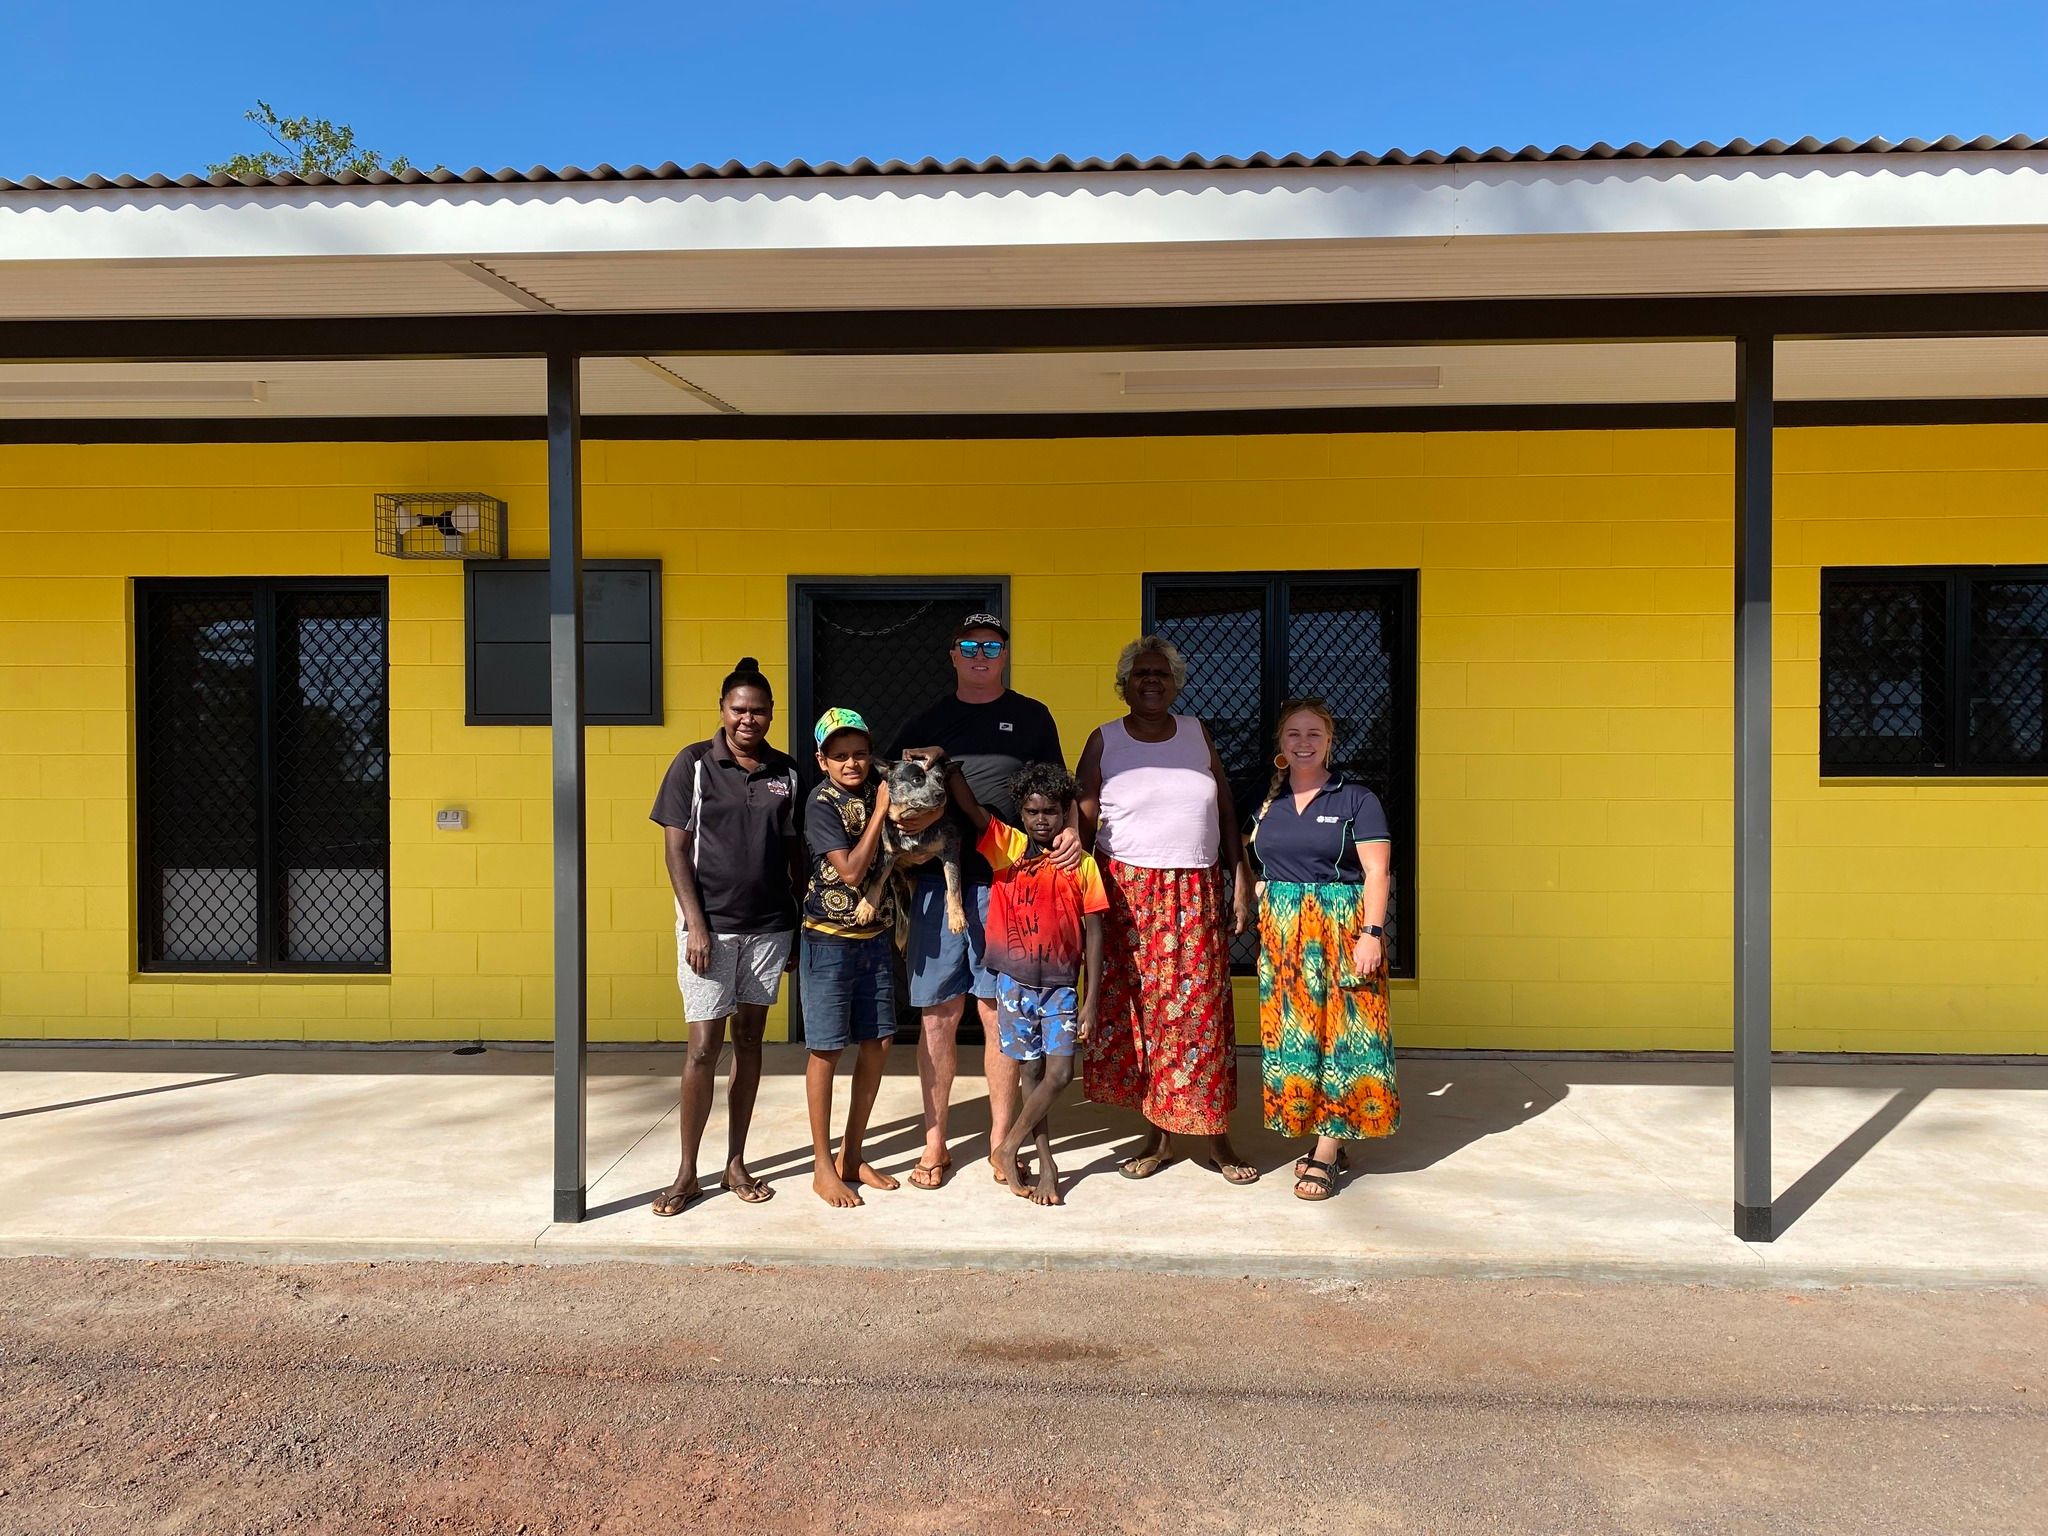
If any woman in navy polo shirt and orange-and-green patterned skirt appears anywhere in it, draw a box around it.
[1251,698,1401,1200]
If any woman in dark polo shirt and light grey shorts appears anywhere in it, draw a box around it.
[649,655,805,1217]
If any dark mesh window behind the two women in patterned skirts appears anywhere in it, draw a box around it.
[1143,571,1415,977]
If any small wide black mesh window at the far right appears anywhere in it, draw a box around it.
[1821,565,2048,776]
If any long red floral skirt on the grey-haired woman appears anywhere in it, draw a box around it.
[1081,858,1237,1137]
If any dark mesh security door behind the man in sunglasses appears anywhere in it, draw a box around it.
[788,575,1010,1040]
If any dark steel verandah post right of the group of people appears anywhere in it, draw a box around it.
[1735,336,1776,1243]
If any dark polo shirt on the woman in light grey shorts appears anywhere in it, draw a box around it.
[647,731,797,934]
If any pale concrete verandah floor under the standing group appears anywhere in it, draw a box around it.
[0,1047,2048,1286]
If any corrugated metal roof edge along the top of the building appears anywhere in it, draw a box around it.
[0,133,2048,193]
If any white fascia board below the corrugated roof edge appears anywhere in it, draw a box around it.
[0,150,2048,262]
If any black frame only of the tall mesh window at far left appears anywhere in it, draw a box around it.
[129,575,391,977]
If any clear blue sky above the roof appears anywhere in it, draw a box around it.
[0,0,2048,176]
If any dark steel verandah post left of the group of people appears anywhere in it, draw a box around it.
[547,352,590,1221]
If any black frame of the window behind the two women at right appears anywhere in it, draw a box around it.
[1139,569,1421,981]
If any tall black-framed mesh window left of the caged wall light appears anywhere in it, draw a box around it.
[135,580,391,971]
